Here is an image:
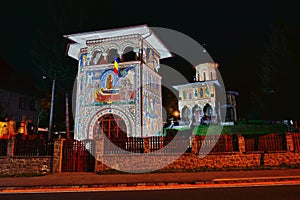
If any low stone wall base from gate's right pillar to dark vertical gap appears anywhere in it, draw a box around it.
[95,153,262,172]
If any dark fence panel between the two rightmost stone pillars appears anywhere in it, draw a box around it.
[244,134,287,152]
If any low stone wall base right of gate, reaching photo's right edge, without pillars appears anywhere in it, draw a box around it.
[95,152,300,172]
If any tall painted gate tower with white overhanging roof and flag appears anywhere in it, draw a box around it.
[65,25,171,140]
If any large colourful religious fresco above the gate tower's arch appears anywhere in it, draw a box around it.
[85,66,135,106]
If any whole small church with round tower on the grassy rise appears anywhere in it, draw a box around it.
[173,63,239,126]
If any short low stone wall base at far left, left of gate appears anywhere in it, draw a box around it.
[0,157,51,175]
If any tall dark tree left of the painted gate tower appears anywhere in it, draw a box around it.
[31,0,83,130]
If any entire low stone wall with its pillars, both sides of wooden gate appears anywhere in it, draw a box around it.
[0,133,300,175]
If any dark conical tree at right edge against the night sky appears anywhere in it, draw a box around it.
[257,19,300,119]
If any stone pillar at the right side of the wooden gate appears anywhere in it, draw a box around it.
[94,137,104,172]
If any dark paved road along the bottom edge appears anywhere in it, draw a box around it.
[0,185,300,200]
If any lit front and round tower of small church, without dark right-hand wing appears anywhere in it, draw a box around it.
[173,63,221,125]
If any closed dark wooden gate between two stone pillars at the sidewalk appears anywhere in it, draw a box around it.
[61,140,95,172]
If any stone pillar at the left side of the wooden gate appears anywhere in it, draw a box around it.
[50,139,65,173]
